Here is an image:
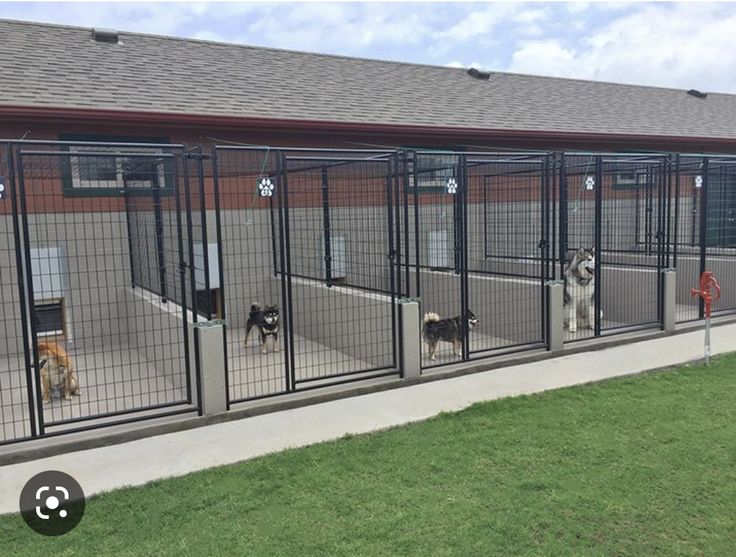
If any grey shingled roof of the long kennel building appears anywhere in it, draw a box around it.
[0,20,736,139]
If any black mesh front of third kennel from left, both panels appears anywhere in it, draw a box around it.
[405,151,552,368]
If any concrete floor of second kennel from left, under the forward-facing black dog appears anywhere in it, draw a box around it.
[227,329,390,401]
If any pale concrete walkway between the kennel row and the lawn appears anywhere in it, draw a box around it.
[0,324,736,513]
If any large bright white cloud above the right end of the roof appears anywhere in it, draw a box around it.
[508,4,736,92]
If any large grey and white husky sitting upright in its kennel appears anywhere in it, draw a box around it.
[563,248,603,333]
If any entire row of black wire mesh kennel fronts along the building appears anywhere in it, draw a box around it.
[0,142,736,443]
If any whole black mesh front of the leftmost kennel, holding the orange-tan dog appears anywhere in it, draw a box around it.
[0,141,200,443]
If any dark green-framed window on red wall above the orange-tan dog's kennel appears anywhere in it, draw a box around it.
[60,136,173,196]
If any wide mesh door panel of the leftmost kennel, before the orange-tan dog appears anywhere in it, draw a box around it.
[3,142,198,435]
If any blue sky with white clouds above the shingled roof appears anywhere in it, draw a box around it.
[0,2,736,93]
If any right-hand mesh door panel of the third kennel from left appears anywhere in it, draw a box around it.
[465,154,552,354]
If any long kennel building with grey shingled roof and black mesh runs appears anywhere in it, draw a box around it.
[0,21,736,443]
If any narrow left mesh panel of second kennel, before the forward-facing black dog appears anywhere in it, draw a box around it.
[214,147,290,402]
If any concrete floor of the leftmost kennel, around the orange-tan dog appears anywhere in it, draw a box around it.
[0,338,187,441]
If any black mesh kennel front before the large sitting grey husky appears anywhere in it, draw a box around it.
[557,153,672,341]
